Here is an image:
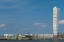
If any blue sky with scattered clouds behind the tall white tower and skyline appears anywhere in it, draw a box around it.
[0,0,64,35]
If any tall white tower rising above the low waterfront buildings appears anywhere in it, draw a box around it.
[53,7,59,36]
